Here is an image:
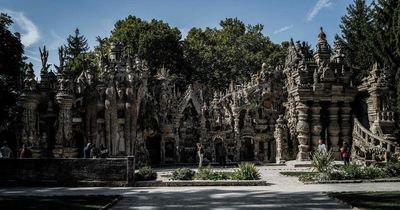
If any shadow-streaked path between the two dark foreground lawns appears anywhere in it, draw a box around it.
[113,189,348,209]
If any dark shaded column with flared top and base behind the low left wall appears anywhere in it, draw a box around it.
[53,92,79,158]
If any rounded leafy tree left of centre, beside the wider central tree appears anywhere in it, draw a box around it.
[111,15,184,79]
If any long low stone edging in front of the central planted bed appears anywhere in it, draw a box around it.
[135,180,270,187]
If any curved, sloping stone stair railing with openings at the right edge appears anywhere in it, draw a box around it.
[352,118,400,161]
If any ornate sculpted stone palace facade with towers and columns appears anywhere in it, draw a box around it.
[20,28,395,164]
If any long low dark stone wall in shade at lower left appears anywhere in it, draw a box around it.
[0,157,134,186]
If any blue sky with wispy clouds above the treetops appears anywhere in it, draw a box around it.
[0,0,353,75]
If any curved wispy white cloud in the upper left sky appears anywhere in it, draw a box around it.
[0,9,40,47]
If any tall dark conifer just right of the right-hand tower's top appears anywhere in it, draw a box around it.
[340,0,375,84]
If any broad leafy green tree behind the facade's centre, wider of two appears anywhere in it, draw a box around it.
[184,18,284,90]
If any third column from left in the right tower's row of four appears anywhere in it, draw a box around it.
[328,103,340,159]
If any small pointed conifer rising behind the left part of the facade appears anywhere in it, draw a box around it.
[64,28,89,79]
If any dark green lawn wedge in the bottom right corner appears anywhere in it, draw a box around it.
[329,191,400,209]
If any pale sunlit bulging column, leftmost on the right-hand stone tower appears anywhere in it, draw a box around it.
[296,102,310,161]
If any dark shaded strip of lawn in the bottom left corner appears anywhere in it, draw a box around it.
[0,196,118,210]
